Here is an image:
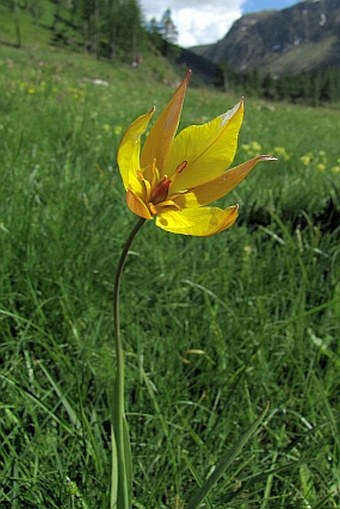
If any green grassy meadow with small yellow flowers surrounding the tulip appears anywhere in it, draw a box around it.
[0,40,340,509]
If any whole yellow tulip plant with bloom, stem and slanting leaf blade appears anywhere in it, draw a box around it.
[110,71,276,509]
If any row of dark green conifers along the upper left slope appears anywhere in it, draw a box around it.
[1,0,178,62]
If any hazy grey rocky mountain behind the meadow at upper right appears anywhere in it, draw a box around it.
[191,0,340,75]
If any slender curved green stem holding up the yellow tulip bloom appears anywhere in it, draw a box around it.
[110,218,145,509]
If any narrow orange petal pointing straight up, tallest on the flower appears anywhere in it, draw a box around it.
[141,71,191,177]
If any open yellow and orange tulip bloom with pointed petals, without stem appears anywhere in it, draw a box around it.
[117,71,276,236]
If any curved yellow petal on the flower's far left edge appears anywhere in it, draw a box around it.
[117,108,155,189]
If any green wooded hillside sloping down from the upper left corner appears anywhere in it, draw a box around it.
[0,0,224,88]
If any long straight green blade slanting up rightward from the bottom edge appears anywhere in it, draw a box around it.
[186,403,269,509]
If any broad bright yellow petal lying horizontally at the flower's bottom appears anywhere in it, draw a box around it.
[156,205,238,237]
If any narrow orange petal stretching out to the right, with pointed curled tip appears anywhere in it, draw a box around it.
[192,156,276,205]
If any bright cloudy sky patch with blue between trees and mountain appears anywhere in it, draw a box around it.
[139,0,298,48]
